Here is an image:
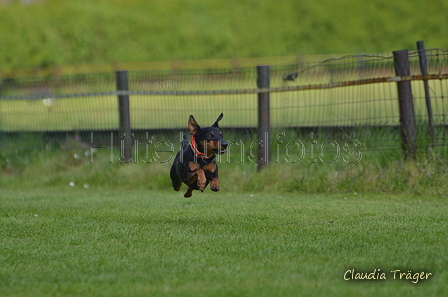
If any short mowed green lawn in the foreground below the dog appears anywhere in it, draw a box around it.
[0,185,448,296]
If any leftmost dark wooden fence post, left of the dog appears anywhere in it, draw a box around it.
[115,71,132,163]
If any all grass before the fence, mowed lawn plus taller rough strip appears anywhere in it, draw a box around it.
[0,114,448,296]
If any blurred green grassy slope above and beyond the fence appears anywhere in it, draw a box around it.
[0,0,448,77]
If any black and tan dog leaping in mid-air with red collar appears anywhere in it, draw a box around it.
[170,113,228,198]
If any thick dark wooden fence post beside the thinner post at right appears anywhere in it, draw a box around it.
[393,50,417,159]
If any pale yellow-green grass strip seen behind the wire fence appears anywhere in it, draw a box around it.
[0,81,448,131]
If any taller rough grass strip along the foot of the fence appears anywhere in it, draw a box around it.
[0,131,448,197]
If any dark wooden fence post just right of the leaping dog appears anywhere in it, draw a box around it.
[257,65,271,171]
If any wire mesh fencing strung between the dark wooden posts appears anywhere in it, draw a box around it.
[0,49,448,154]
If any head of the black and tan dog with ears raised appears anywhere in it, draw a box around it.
[188,113,228,157]
